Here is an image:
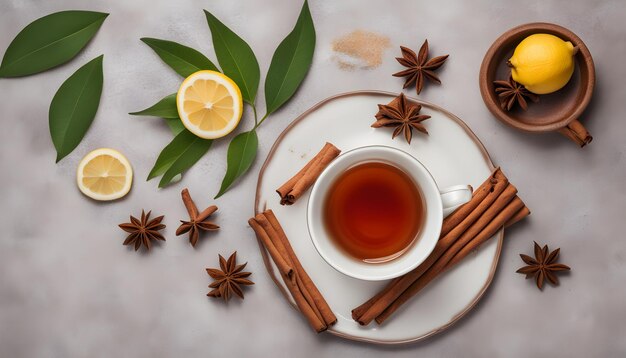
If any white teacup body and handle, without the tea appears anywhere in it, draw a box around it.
[307,146,472,281]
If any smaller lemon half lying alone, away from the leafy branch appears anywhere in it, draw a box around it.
[76,148,133,201]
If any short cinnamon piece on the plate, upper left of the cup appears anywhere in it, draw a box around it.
[276,143,341,205]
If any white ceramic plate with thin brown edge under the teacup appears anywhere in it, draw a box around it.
[255,91,503,344]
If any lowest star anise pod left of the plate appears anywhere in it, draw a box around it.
[206,251,254,301]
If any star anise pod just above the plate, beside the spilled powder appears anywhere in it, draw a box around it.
[393,40,449,94]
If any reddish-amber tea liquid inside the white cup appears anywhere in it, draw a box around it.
[323,161,425,263]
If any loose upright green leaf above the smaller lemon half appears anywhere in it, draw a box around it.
[48,55,104,163]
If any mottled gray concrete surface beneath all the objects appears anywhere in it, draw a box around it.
[0,0,626,358]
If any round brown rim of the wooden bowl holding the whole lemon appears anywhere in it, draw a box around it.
[478,22,595,132]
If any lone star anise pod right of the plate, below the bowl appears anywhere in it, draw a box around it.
[516,242,570,290]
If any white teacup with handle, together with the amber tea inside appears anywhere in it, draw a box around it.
[306,145,472,281]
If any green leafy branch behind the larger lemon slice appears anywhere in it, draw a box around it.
[130,1,315,198]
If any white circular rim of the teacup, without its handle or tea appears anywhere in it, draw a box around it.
[306,145,443,281]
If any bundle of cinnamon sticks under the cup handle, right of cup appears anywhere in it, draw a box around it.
[352,168,530,325]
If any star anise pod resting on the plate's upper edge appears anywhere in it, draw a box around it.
[372,93,430,144]
